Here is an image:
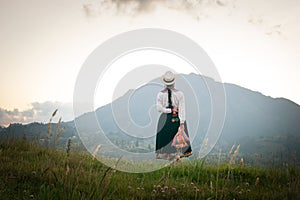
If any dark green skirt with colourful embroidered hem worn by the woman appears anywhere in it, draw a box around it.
[155,113,192,159]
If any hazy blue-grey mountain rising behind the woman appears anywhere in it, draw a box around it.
[0,74,300,164]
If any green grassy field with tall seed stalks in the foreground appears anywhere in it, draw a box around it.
[0,141,300,199]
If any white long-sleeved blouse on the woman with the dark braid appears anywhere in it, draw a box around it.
[156,89,185,123]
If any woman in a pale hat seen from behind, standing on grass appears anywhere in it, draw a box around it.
[155,71,192,160]
